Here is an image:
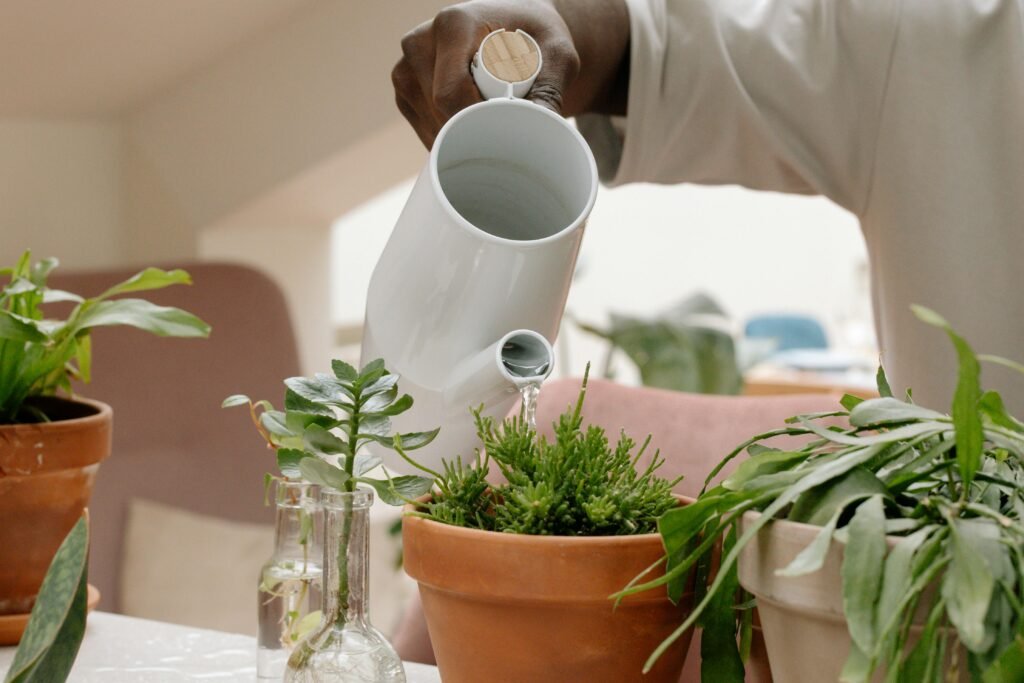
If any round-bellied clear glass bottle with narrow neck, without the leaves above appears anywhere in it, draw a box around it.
[285,488,406,683]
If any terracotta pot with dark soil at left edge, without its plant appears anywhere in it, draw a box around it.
[0,397,112,614]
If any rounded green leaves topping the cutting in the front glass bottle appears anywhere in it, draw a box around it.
[221,359,438,505]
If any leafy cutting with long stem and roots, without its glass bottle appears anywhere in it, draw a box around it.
[224,359,438,680]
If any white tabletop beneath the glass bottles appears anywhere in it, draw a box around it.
[0,612,441,683]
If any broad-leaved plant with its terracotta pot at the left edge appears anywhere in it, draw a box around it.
[0,252,210,634]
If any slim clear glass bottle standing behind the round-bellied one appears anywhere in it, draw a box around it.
[256,479,324,681]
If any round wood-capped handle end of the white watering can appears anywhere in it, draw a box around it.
[470,29,543,99]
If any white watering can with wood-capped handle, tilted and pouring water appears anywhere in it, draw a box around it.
[362,31,597,472]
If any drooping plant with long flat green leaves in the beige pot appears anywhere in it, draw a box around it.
[620,307,1024,683]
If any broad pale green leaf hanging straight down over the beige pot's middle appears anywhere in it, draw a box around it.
[842,496,886,652]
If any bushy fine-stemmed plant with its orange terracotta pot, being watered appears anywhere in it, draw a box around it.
[396,368,689,683]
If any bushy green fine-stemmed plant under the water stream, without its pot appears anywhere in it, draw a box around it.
[405,367,681,536]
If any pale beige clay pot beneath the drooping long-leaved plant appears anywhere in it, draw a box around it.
[739,512,970,683]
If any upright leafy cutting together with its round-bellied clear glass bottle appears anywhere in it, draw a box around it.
[224,359,437,683]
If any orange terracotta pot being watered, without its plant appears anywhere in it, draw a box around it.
[402,507,692,683]
